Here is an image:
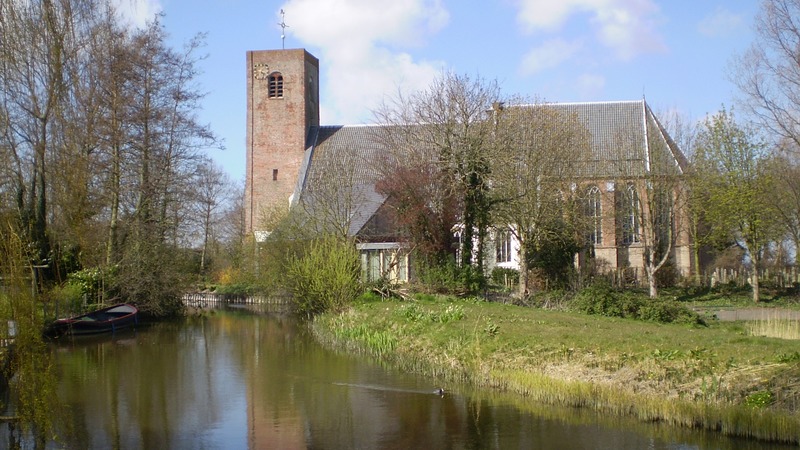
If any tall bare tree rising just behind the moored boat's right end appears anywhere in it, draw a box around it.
[112,20,215,314]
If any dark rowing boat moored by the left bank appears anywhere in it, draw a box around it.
[45,303,139,337]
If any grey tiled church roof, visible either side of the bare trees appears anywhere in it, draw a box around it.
[295,100,686,235]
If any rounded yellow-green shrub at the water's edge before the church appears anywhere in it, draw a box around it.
[286,236,362,318]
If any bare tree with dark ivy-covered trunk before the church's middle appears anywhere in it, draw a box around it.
[376,72,500,283]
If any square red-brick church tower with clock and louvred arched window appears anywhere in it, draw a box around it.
[244,49,319,233]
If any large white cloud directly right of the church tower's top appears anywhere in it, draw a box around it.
[282,0,449,123]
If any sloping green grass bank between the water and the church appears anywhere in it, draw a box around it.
[313,296,800,443]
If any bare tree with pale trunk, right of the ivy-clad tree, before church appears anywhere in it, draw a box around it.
[491,101,589,296]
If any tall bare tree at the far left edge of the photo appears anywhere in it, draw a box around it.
[0,0,76,264]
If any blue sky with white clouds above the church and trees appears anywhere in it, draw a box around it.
[116,0,760,181]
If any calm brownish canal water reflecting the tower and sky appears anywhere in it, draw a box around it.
[0,309,788,449]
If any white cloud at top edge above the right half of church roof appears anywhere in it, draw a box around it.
[518,0,664,60]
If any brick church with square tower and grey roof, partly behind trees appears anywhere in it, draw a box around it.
[245,49,691,280]
